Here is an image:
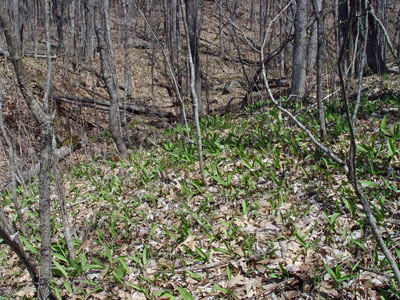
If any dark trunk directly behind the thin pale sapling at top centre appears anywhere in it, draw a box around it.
[185,0,204,115]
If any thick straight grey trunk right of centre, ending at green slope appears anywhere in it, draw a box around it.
[290,0,307,98]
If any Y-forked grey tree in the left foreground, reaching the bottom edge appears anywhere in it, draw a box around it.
[0,0,53,299]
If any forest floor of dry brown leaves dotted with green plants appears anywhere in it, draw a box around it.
[0,2,400,300]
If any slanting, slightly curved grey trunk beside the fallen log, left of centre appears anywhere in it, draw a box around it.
[94,0,128,159]
